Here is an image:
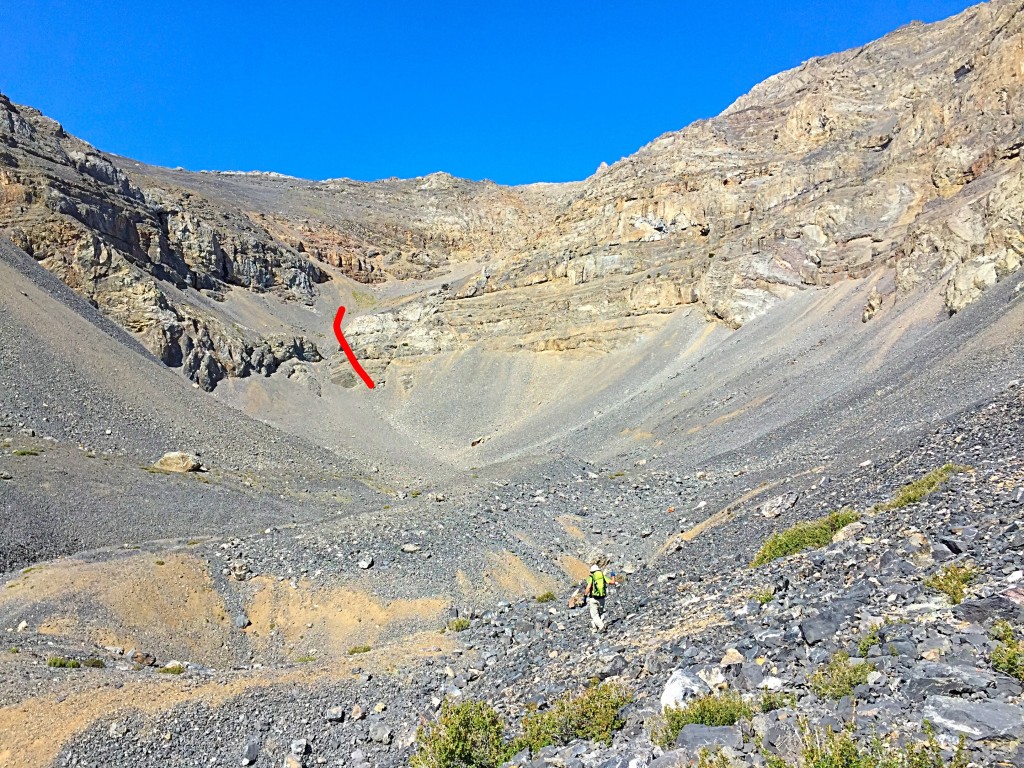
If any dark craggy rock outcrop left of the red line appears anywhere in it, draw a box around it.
[0,97,326,390]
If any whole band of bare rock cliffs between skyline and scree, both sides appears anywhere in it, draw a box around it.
[0,0,1024,388]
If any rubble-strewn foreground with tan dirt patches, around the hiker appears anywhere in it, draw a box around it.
[0,342,1024,767]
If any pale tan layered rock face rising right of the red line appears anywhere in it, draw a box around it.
[335,2,1024,382]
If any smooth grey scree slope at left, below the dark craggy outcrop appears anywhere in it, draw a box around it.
[0,240,380,570]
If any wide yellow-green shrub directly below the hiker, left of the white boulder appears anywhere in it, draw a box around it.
[513,683,633,754]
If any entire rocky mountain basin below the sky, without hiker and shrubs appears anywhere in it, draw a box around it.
[0,0,1024,768]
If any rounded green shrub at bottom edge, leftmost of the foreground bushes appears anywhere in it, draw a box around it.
[410,701,515,768]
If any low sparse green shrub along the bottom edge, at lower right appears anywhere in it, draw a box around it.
[763,722,968,768]
